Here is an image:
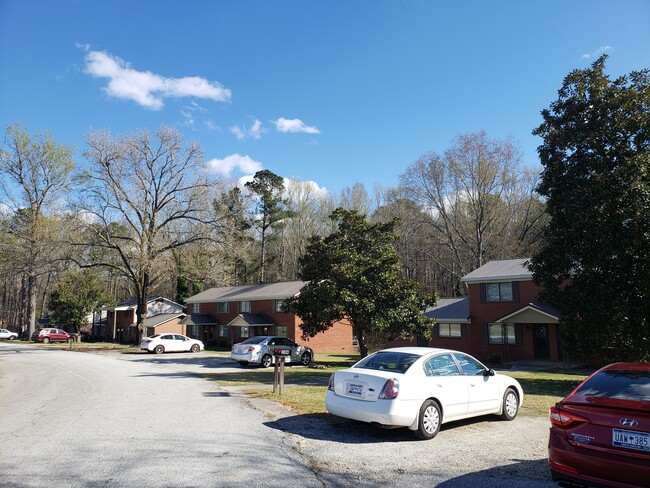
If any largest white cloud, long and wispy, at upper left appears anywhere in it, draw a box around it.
[86,51,231,110]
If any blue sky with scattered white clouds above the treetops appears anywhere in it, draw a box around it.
[0,0,650,194]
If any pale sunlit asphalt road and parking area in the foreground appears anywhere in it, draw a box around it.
[0,342,555,488]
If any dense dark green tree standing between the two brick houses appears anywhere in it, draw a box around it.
[287,208,435,356]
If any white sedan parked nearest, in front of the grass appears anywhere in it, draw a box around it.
[325,347,524,439]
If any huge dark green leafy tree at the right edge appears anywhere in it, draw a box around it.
[532,56,650,360]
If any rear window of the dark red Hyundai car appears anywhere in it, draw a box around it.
[575,370,650,402]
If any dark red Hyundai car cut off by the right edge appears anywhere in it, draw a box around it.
[548,363,650,487]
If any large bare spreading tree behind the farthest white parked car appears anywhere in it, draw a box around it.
[78,127,210,335]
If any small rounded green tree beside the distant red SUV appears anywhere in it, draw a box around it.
[49,270,113,331]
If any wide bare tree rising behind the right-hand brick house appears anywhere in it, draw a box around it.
[401,131,543,290]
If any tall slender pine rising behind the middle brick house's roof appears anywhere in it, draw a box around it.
[246,169,291,282]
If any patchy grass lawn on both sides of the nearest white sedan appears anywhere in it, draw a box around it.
[204,355,588,416]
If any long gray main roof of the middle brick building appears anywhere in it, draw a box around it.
[186,281,307,303]
